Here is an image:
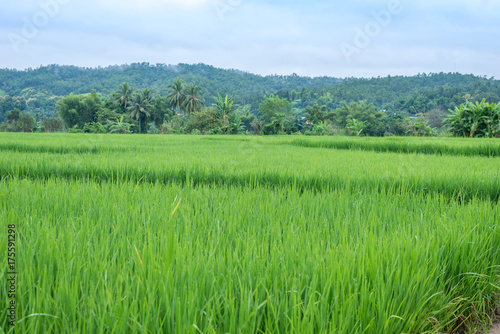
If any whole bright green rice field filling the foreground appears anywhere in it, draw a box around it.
[0,133,500,333]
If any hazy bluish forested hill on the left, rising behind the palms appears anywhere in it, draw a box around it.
[0,63,342,103]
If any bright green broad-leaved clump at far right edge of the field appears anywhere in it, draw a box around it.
[446,99,500,138]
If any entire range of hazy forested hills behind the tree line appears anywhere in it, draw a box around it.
[0,63,500,121]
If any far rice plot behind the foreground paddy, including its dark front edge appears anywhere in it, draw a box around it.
[0,135,500,202]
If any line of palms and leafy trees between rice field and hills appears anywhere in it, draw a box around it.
[0,77,500,137]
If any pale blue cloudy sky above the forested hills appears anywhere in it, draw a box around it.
[0,0,500,79]
